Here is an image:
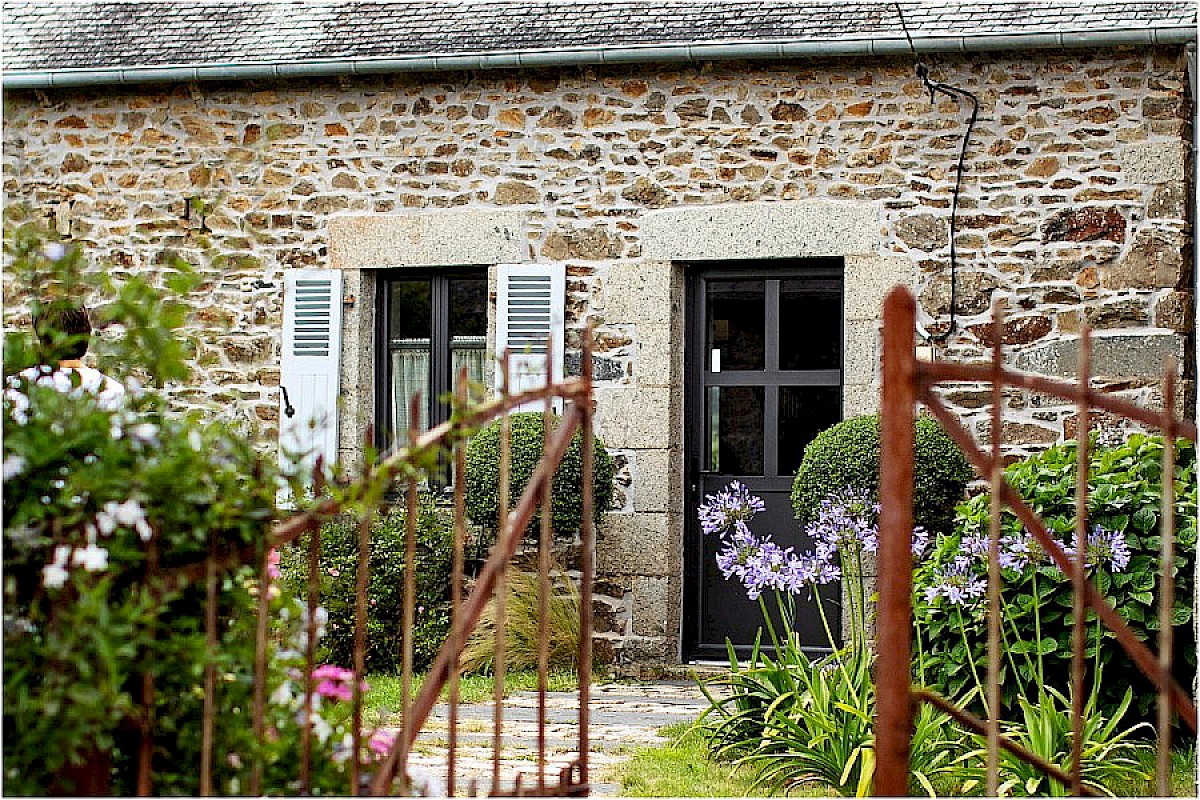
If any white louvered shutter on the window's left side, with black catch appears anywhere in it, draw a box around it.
[280,270,342,480]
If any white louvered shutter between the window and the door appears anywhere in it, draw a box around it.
[496,264,566,411]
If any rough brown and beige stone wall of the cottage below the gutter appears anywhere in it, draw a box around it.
[4,48,1194,660]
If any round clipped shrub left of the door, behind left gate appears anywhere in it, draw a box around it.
[466,411,613,536]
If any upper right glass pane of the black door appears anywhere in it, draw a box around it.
[779,279,841,369]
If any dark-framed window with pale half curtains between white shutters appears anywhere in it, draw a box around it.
[376,269,490,451]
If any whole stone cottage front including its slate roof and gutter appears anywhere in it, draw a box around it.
[4,2,1195,662]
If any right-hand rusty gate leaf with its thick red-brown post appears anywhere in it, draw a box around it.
[874,287,1196,796]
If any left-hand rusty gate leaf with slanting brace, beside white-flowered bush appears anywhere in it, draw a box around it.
[119,330,595,796]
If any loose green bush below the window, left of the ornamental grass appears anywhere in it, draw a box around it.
[280,506,454,673]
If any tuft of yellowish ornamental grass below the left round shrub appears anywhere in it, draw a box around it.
[462,566,580,673]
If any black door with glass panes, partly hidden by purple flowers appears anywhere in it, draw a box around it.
[684,259,842,658]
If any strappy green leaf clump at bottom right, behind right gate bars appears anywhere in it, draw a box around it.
[961,688,1151,798]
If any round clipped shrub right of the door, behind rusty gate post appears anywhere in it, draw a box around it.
[792,414,974,531]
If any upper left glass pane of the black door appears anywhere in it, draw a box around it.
[706,281,767,372]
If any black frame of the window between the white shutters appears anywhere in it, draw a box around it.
[374,266,491,451]
